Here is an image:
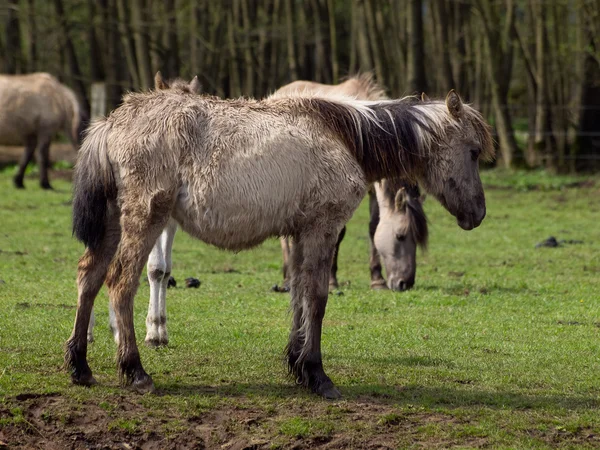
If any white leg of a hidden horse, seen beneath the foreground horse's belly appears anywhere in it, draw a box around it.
[145,219,177,347]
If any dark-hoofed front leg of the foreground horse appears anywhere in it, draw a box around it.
[288,233,340,398]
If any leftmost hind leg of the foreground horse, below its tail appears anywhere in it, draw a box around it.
[65,207,120,386]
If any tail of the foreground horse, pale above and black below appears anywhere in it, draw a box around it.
[73,120,117,250]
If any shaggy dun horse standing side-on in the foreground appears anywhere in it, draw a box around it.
[65,83,494,398]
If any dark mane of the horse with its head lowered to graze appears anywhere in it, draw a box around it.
[381,178,429,250]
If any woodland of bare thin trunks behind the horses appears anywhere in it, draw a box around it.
[0,0,600,172]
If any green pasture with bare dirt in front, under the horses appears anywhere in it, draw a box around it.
[0,170,600,449]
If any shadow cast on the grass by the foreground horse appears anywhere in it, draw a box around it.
[156,383,600,410]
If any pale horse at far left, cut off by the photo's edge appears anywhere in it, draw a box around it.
[0,73,87,189]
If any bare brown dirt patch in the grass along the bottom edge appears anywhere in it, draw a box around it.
[0,393,485,450]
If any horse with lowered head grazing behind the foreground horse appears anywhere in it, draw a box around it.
[272,73,428,292]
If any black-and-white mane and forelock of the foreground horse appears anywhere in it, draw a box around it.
[294,94,494,182]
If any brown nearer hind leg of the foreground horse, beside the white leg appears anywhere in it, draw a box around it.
[106,192,173,392]
